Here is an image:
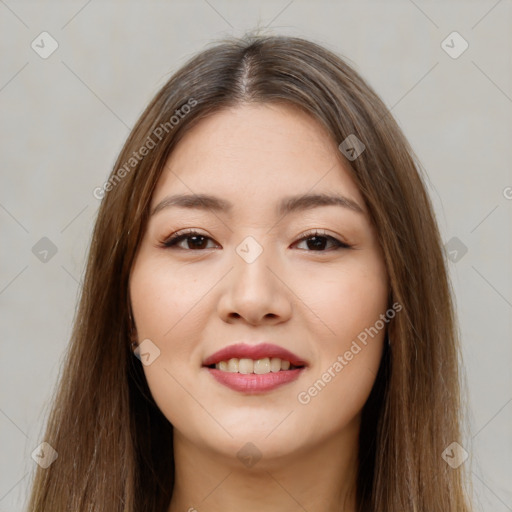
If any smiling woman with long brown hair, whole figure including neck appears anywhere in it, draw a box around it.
[24,36,470,512]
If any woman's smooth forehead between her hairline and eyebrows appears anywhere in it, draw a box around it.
[152,104,364,215]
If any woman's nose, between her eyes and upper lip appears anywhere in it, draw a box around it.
[217,239,293,325]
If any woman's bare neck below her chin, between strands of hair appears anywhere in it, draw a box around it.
[168,418,360,512]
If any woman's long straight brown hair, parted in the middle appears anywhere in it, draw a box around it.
[28,34,470,512]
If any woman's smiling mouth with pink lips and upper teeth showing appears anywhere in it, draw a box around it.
[203,343,307,394]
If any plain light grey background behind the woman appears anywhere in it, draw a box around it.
[0,0,512,512]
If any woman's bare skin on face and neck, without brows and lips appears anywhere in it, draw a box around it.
[130,104,389,512]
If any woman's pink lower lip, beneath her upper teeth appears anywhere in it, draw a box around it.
[207,368,304,394]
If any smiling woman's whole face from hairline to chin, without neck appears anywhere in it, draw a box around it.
[130,104,388,459]
